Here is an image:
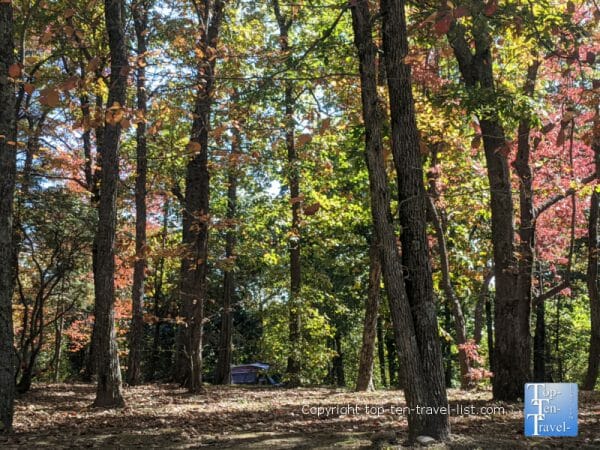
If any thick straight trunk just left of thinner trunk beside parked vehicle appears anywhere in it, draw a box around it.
[179,0,225,393]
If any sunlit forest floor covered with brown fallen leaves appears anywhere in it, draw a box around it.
[0,384,600,450]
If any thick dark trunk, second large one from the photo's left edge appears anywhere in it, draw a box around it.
[94,0,128,408]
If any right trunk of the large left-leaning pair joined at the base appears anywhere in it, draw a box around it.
[381,0,450,438]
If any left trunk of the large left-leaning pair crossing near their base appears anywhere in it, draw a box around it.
[351,1,449,439]
